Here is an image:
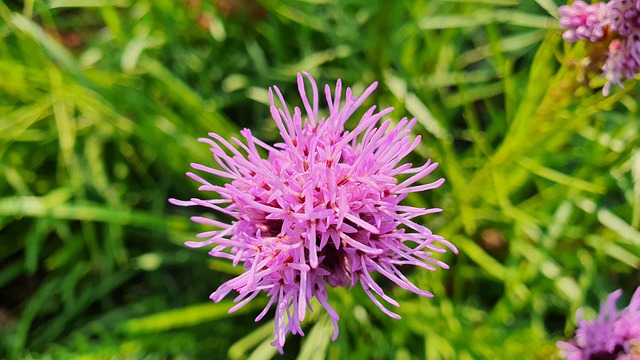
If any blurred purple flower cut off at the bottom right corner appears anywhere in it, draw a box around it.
[557,287,640,360]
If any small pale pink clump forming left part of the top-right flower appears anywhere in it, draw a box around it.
[559,0,607,42]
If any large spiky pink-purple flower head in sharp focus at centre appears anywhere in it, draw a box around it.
[170,73,457,350]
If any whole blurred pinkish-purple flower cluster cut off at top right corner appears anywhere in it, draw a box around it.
[559,0,640,96]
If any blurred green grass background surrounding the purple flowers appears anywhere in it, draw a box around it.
[0,0,640,360]
